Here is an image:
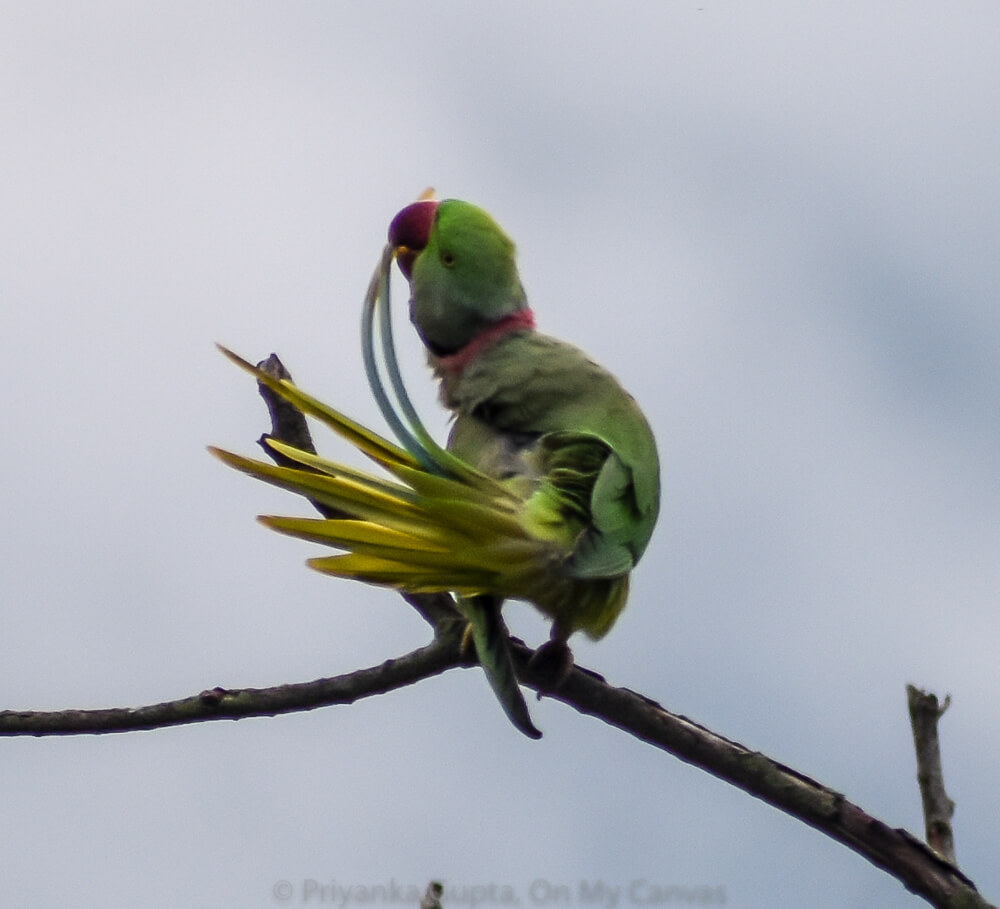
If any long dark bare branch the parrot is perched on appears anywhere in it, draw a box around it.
[0,358,996,909]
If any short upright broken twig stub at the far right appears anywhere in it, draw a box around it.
[906,685,955,864]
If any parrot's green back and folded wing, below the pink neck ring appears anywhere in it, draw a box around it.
[438,331,660,638]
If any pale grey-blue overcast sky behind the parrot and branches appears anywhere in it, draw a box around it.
[0,0,1000,909]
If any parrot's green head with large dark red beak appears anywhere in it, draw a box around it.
[389,199,528,357]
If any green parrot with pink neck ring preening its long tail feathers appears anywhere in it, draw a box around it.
[215,199,659,738]
